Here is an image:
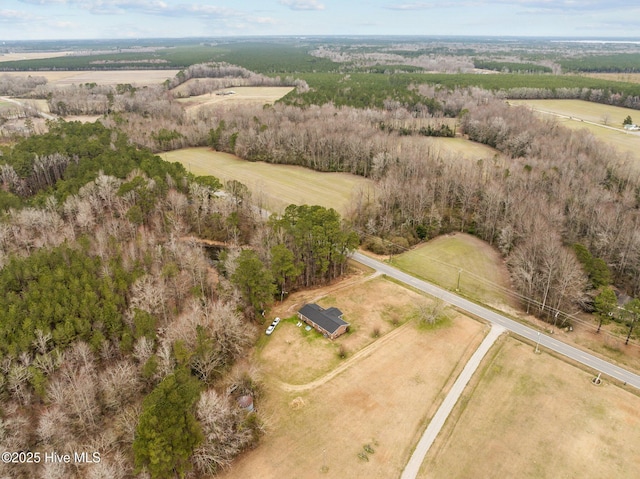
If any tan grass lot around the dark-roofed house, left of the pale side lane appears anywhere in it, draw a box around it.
[219,279,485,479]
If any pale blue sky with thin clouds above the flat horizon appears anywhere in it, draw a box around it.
[0,0,640,40]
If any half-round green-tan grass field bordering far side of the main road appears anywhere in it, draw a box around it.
[391,233,515,309]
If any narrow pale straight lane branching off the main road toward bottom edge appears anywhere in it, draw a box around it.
[400,324,504,479]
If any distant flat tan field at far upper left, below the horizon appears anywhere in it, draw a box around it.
[0,70,178,86]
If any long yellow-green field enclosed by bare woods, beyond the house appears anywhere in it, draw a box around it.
[160,148,373,214]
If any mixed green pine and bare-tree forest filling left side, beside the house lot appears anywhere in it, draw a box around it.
[0,122,358,478]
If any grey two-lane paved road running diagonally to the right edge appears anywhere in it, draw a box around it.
[352,252,640,389]
